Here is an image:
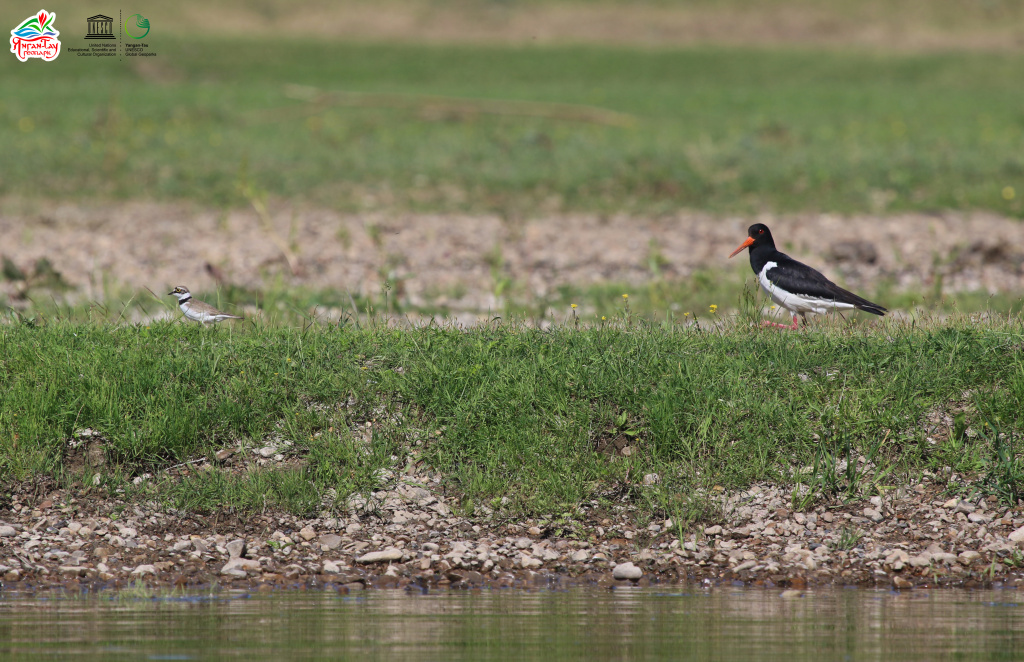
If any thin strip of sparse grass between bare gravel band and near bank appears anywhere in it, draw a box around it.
[9,270,1024,327]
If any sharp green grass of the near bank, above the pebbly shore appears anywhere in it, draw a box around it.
[0,316,1024,520]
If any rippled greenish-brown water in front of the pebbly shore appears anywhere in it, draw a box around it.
[0,587,1024,662]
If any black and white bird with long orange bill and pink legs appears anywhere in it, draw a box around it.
[729,223,886,330]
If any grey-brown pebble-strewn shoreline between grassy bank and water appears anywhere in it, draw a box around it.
[0,477,1024,591]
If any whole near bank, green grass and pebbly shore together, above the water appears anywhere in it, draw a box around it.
[0,319,1024,589]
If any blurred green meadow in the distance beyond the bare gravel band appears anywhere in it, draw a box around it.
[0,37,1024,219]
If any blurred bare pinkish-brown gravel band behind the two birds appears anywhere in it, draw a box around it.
[0,200,1024,311]
